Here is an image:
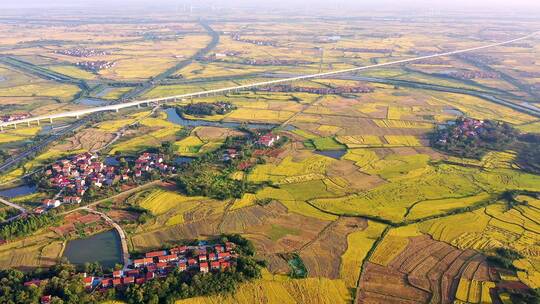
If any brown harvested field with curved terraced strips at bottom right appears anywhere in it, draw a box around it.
[358,235,496,303]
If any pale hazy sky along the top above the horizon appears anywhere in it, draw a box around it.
[0,0,540,12]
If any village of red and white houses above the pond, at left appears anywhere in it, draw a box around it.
[40,152,176,214]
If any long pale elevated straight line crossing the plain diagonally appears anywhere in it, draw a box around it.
[0,32,540,129]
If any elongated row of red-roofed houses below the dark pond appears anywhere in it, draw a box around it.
[88,242,237,289]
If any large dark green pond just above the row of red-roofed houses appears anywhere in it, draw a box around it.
[63,230,122,268]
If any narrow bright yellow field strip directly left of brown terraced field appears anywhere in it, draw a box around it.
[339,221,386,287]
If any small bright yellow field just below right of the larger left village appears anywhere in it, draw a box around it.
[139,189,201,216]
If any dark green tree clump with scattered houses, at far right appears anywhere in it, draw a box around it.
[431,118,518,159]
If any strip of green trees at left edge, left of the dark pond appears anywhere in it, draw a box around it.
[0,213,58,240]
